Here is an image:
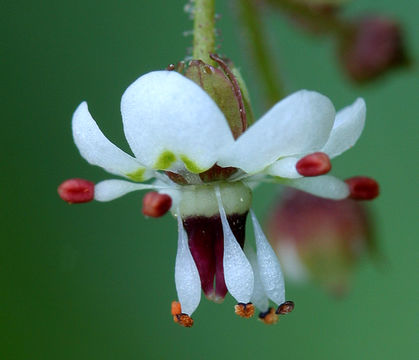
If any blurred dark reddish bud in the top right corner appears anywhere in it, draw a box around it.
[339,16,408,82]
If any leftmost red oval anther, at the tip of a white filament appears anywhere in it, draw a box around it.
[58,179,95,204]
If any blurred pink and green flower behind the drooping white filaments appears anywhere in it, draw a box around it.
[268,189,372,296]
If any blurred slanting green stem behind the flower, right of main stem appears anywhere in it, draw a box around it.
[239,0,286,106]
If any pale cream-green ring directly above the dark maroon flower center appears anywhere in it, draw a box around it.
[179,181,252,219]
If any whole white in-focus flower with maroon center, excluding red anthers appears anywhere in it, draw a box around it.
[73,71,365,324]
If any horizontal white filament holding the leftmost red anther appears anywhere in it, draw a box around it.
[95,180,156,201]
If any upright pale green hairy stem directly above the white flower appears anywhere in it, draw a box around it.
[192,0,215,65]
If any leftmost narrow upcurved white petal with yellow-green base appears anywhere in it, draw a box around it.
[72,102,150,181]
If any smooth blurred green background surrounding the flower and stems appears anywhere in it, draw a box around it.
[0,0,419,360]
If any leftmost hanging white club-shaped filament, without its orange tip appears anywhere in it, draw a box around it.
[175,211,201,316]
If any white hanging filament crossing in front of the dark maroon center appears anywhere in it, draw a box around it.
[216,187,254,304]
